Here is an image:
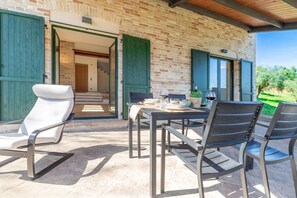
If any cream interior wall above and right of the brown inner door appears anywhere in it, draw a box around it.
[75,55,98,91]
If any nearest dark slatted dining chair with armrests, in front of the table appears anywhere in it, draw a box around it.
[161,101,263,198]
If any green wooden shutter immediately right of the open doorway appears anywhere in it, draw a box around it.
[123,35,150,119]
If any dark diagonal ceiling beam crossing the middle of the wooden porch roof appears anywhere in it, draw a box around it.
[214,0,282,28]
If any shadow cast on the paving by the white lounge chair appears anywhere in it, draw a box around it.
[0,144,128,185]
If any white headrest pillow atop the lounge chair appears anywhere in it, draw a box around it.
[32,84,74,99]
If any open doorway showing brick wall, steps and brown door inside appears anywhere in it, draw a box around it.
[52,26,117,118]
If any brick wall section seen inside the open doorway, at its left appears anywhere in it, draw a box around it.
[60,41,75,89]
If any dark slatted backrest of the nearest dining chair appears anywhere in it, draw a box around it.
[201,101,263,148]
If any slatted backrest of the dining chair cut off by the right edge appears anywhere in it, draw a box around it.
[266,102,297,139]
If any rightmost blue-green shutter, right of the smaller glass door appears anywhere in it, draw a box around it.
[240,59,254,101]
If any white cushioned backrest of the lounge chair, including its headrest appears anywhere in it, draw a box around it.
[18,84,74,143]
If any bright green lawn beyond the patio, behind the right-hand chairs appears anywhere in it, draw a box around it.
[258,93,295,115]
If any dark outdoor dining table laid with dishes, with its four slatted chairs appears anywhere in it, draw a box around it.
[127,92,297,197]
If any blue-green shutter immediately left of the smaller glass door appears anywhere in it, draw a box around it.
[191,49,210,102]
